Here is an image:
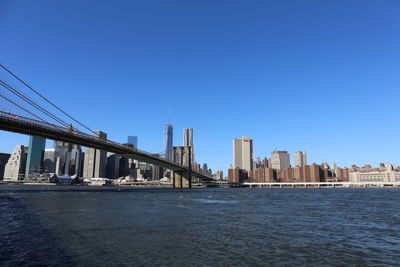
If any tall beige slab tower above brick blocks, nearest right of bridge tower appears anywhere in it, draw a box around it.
[233,136,253,171]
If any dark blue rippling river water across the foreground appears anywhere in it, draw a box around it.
[0,185,400,266]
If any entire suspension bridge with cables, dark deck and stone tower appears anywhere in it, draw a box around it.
[0,64,214,188]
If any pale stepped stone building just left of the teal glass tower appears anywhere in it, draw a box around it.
[3,145,29,182]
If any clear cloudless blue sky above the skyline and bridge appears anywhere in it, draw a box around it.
[0,0,400,170]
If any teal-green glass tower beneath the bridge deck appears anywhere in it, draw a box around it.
[25,136,46,179]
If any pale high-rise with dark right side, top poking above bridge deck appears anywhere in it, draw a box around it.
[83,131,107,178]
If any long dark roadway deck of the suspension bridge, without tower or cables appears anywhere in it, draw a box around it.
[0,111,214,181]
